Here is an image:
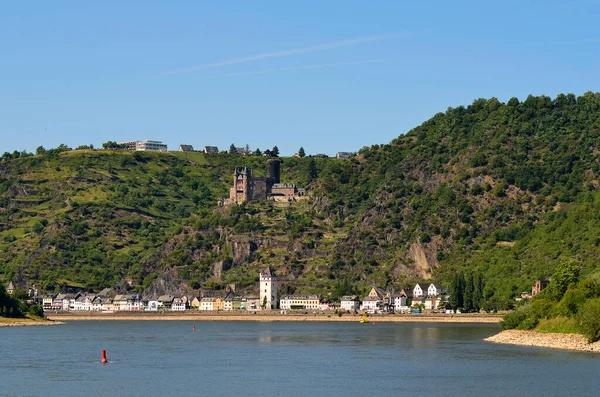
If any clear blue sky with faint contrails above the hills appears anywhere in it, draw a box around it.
[0,0,600,155]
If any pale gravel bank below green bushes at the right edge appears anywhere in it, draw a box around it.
[484,329,600,353]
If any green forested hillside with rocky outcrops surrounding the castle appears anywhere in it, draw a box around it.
[0,93,600,308]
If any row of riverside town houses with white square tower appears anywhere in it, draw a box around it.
[15,267,460,314]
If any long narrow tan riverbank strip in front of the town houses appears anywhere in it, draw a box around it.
[46,312,502,324]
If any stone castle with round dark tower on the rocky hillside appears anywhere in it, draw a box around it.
[224,159,304,205]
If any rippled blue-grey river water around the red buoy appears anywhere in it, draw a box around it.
[0,321,600,397]
